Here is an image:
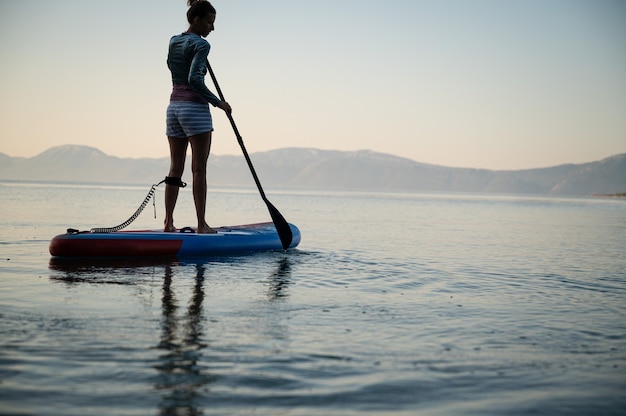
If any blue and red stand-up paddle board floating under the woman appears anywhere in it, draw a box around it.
[50,222,300,257]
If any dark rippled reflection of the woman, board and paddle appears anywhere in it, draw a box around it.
[49,256,292,415]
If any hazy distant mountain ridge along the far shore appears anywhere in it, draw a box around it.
[0,145,626,195]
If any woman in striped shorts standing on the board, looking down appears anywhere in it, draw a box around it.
[164,0,231,233]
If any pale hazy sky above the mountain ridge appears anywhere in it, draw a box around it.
[0,0,626,169]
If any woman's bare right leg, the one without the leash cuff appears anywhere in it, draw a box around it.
[189,132,216,234]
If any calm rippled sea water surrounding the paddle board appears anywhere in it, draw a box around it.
[0,182,626,416]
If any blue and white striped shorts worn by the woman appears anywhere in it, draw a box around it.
[166,101,213,139]
